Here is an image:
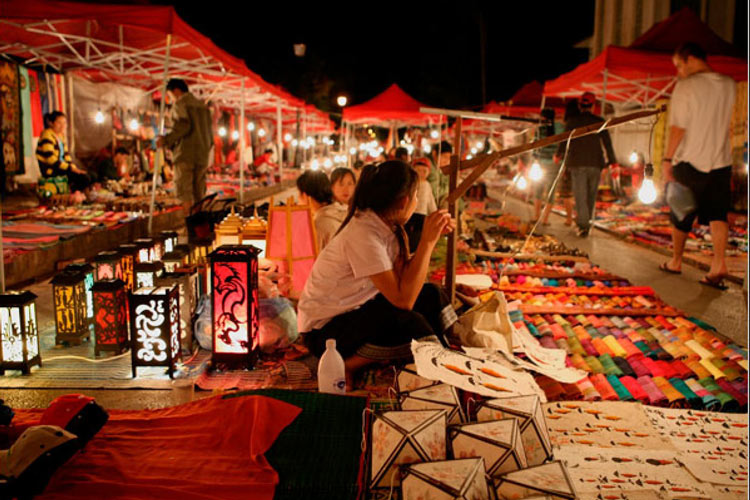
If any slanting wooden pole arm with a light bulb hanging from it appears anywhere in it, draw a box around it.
[448,106,666,205]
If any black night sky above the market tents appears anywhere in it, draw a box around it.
[157,0,594,110]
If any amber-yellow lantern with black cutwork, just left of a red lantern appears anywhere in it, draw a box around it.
[50,271,90,345]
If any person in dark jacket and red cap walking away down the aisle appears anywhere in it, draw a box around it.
[556,92,617,237]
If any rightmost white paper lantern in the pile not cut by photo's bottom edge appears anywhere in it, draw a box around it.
[477,395,552,465]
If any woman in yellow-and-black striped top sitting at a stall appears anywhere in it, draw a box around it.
[36,111,91,192]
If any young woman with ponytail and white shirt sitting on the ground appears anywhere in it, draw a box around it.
[298,161,455,390]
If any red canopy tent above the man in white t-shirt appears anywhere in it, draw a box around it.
[544,9,747,106]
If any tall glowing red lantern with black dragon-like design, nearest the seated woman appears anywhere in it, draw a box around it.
[209,245,260,367]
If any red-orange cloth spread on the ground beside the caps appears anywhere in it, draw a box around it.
[14,396,301,500]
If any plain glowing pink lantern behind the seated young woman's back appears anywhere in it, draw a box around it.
[266,198,318,297]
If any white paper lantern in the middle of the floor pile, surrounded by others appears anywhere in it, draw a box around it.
[448,418,527,476]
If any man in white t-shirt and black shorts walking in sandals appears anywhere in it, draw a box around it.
[659,43,737,290]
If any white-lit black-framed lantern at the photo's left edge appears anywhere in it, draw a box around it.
[0,291,42,375]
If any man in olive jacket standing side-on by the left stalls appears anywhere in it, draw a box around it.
[158,78,213,215]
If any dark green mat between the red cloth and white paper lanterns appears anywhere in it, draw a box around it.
[225,389,367,500]
